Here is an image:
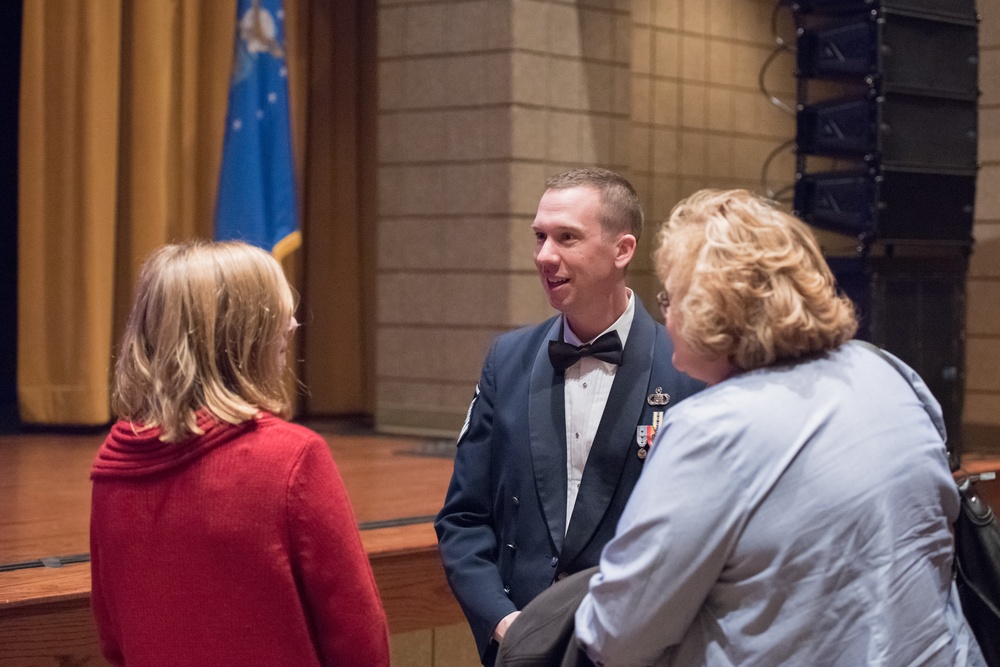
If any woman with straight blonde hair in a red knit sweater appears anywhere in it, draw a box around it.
[90,242,389,667]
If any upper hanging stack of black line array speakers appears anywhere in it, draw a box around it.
[792,0,979,243]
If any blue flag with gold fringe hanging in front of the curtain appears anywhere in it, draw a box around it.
[215,0,302,259]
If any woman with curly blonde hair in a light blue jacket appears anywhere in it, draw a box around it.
[576,190,983,667]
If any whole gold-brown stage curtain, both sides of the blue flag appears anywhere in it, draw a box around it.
[18,0,375,425]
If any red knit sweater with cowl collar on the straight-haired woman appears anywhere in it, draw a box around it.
[90,415,389,667]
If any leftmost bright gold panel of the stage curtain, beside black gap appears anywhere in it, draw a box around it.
[18,0,128,424]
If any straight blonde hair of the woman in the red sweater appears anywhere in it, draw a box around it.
[112,241,295,442]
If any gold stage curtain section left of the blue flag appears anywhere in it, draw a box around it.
[18,0,290,424]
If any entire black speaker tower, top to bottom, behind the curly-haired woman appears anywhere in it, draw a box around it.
[786,0,979,465]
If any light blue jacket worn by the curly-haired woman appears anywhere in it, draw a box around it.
[576,344,983,667]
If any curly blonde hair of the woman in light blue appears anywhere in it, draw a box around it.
[655,190,858,371]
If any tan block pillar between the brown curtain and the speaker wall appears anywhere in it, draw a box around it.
[376,0,631,436]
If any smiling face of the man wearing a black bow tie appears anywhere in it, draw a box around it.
[531,187,635,330]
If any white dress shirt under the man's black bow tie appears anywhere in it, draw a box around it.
[563,290,635,529]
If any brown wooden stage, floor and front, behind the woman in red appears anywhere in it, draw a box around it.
[0,424,463,666]
